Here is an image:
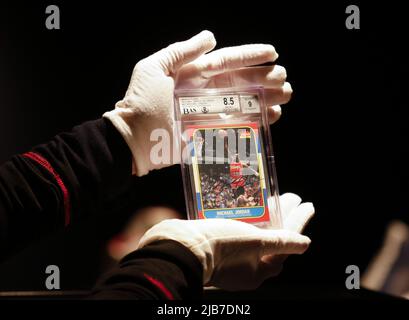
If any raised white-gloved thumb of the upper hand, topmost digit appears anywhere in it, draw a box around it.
[148,30,216,75]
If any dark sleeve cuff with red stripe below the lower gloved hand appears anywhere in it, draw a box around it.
[90,240,203,300]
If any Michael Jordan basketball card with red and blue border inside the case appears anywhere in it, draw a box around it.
[188,122,270,222]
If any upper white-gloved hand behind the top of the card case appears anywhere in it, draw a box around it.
[104,31,292,176]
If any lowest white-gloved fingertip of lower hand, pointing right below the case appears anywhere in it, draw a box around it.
[260,230,311,256]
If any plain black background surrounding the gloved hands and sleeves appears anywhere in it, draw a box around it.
[0,1,409,296]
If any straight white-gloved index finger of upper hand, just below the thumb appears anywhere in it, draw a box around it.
[193,44,278,78]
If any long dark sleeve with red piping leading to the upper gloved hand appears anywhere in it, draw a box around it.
[0,119,132,261]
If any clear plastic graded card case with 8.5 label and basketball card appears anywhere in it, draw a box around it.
[175,86,281,228]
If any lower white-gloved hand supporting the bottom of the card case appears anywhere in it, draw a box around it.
[138,194,314,290]
